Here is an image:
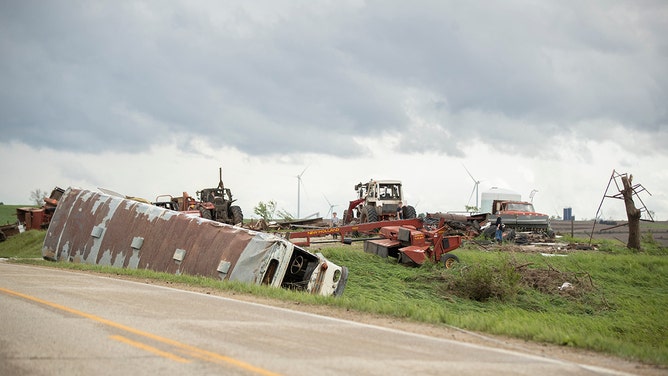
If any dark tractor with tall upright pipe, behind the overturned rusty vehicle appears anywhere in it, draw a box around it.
[196,168,244,225]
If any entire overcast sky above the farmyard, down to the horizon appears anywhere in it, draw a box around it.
[0,0,668,220]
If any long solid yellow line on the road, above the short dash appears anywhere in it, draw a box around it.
[0,287,279,376]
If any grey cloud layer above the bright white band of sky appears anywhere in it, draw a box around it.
[0,1,668,157]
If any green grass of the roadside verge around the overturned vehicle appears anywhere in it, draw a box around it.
[0,231,668,366]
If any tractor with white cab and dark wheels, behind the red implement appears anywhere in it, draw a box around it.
[343,179,417,224]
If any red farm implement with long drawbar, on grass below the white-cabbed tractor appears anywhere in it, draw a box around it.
[287,218,462,269]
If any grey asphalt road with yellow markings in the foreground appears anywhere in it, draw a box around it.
[0,262,636,376]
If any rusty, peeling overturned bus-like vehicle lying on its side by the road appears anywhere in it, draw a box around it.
[42,188,348,295]
